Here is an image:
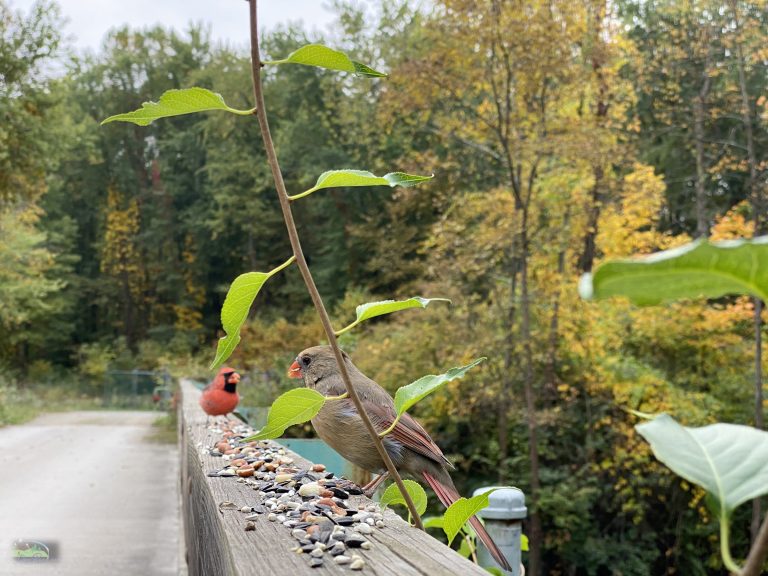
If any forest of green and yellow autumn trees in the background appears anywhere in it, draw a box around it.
[0,0,768,576]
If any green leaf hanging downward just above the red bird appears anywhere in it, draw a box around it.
[210,256,295,370]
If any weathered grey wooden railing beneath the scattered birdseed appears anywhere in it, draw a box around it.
[179,380,488,576]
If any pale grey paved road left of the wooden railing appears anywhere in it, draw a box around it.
[0,412,180,576]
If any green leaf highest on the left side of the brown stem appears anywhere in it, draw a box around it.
[102,88,255,126]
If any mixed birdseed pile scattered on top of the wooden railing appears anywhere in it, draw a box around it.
[202,423,384,570]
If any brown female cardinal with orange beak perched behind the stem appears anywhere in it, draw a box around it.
[288,346,512,570]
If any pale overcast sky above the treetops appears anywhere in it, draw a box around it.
[10,0,340,51]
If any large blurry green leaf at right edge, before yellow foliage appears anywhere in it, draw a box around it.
[579,236,768,306]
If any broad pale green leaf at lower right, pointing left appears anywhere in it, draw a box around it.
[635,414,768,517]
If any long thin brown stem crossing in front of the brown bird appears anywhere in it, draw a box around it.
[248,0,424,530]
